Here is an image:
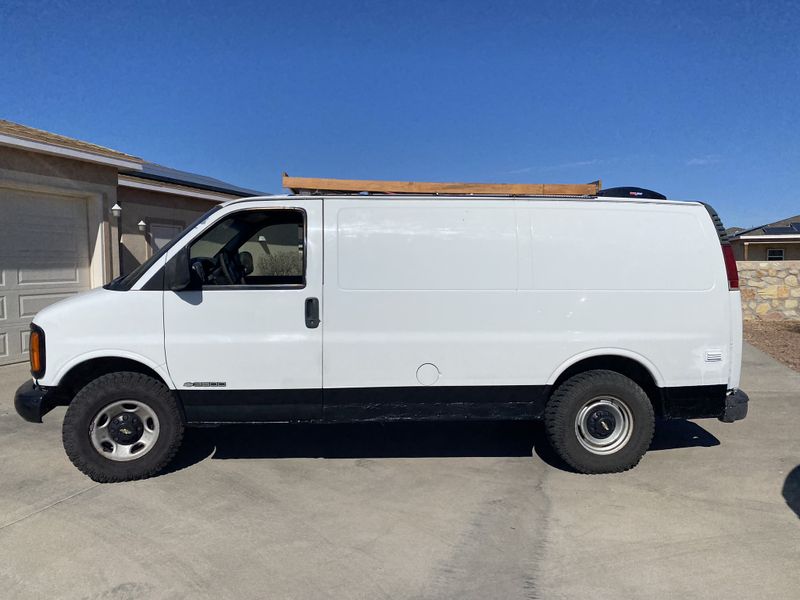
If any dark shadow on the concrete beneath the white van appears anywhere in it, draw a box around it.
[165,421,719,473]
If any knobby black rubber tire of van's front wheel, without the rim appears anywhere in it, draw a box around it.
[62,372,183,483]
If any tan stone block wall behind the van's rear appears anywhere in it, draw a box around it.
[736,260,800,321]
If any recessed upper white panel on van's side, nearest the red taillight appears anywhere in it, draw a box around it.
[522,202,719,293]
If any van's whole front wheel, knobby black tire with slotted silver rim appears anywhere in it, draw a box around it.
[62,372,183,483]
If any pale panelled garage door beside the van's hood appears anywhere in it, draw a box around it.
[0,188,90,365]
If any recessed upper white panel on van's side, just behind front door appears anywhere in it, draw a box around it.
[336,205,517,297]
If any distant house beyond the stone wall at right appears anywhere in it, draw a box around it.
[731,215,800,261]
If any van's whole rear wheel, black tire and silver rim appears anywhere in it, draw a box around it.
[545,370,655,474]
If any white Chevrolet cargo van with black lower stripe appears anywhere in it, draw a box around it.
[16,184,747,482]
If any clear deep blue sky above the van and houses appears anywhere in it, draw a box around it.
[0,0,800,226]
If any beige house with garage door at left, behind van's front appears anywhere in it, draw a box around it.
[0,120,263,365]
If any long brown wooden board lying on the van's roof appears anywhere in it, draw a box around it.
[283,173,601,196]
